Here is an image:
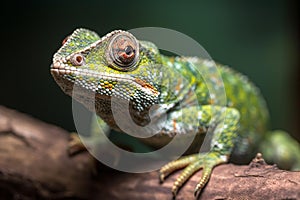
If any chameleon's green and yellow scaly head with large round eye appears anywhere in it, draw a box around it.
[51,29,162,110]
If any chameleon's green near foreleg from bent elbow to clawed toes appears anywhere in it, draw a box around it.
[159,105,240,197]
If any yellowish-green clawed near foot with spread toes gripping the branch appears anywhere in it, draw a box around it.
[159,152,227,198]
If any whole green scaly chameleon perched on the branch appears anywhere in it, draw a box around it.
[51,28,300,196]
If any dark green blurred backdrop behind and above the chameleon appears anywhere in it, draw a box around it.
[0,0,300,139]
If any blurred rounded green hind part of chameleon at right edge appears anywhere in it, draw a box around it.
[260,130,300,171]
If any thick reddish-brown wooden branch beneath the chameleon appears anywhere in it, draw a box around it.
[0,106,300,200]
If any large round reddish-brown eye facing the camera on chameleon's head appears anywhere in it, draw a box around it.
[108,32,139,71]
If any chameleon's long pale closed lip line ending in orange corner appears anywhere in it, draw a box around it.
[50,62,159,96]
